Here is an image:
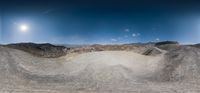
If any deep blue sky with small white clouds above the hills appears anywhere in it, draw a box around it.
[0,0,200,44]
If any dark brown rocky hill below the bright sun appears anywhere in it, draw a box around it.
[5,43,70,58]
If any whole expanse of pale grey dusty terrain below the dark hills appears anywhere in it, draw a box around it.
[0,41,200,93]
